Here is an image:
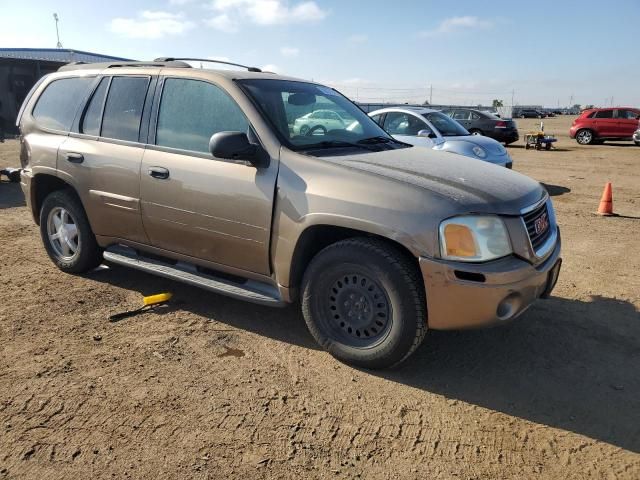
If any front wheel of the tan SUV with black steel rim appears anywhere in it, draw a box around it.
[302,238,427,369]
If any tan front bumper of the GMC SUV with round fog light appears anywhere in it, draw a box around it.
[420,235,562,330]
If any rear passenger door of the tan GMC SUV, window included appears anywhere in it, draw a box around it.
[58,75,152,243]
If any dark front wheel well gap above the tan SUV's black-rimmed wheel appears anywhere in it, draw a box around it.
[289,225,420,291]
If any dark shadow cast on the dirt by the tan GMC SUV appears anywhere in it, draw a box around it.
[88,266,640,452]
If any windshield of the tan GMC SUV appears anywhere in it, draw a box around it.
[238,79,396,150]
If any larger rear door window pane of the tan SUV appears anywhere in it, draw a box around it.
[100,77,149,142]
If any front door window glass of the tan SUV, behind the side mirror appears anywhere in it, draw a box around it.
[156,78,249,153]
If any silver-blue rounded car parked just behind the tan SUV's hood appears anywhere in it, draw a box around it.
[369,107,513,168]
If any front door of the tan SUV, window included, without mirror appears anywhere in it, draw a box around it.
[140,78,278,274]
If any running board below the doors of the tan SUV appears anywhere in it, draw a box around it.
[104,245,286,307]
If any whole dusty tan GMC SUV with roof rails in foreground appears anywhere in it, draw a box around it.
[18,58,561,368]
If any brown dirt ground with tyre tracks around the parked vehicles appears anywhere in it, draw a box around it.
[0,117,640,480]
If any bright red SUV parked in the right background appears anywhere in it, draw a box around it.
[569,108,640,145]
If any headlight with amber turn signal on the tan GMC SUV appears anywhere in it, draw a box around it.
[440,215,513,262]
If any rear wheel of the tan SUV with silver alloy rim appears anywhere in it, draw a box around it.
[40,190,102,273]
